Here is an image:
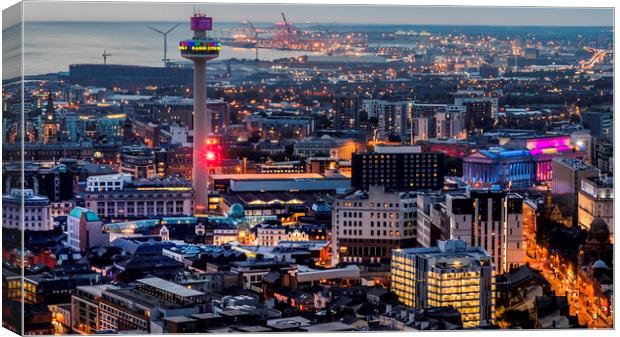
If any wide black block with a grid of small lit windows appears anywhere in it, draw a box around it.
[351,146,444,191]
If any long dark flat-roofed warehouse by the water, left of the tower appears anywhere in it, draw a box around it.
[68,64,193,88]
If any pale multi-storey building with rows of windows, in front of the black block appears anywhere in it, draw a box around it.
[332,186,416,263]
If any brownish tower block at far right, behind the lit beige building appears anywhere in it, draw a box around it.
[551,157,599,226]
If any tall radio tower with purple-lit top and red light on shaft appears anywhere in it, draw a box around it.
[179,13,221,213]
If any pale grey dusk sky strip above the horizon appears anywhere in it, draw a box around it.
[19,1,613,26]
